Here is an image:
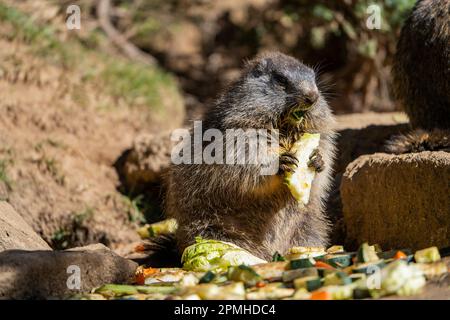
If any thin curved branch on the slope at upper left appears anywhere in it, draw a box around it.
[97,0,157,65]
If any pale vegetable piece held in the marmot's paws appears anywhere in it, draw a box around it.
[285,133,320,206]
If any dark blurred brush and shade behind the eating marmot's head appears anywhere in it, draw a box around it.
[14,0,415,117]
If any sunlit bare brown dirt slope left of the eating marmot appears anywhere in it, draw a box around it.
[0,1,182,249]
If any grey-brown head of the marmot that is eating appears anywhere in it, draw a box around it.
[207,52,331,131]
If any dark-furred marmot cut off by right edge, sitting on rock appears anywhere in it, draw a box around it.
[387,0,450,153]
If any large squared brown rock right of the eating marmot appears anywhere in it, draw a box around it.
[341,152,450,249]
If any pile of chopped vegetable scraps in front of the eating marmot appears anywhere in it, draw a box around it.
[74,234,449,300]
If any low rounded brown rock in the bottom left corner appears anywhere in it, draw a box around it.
[0,244,137,299]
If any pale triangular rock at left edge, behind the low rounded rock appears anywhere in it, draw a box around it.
[0,201,51,252]
